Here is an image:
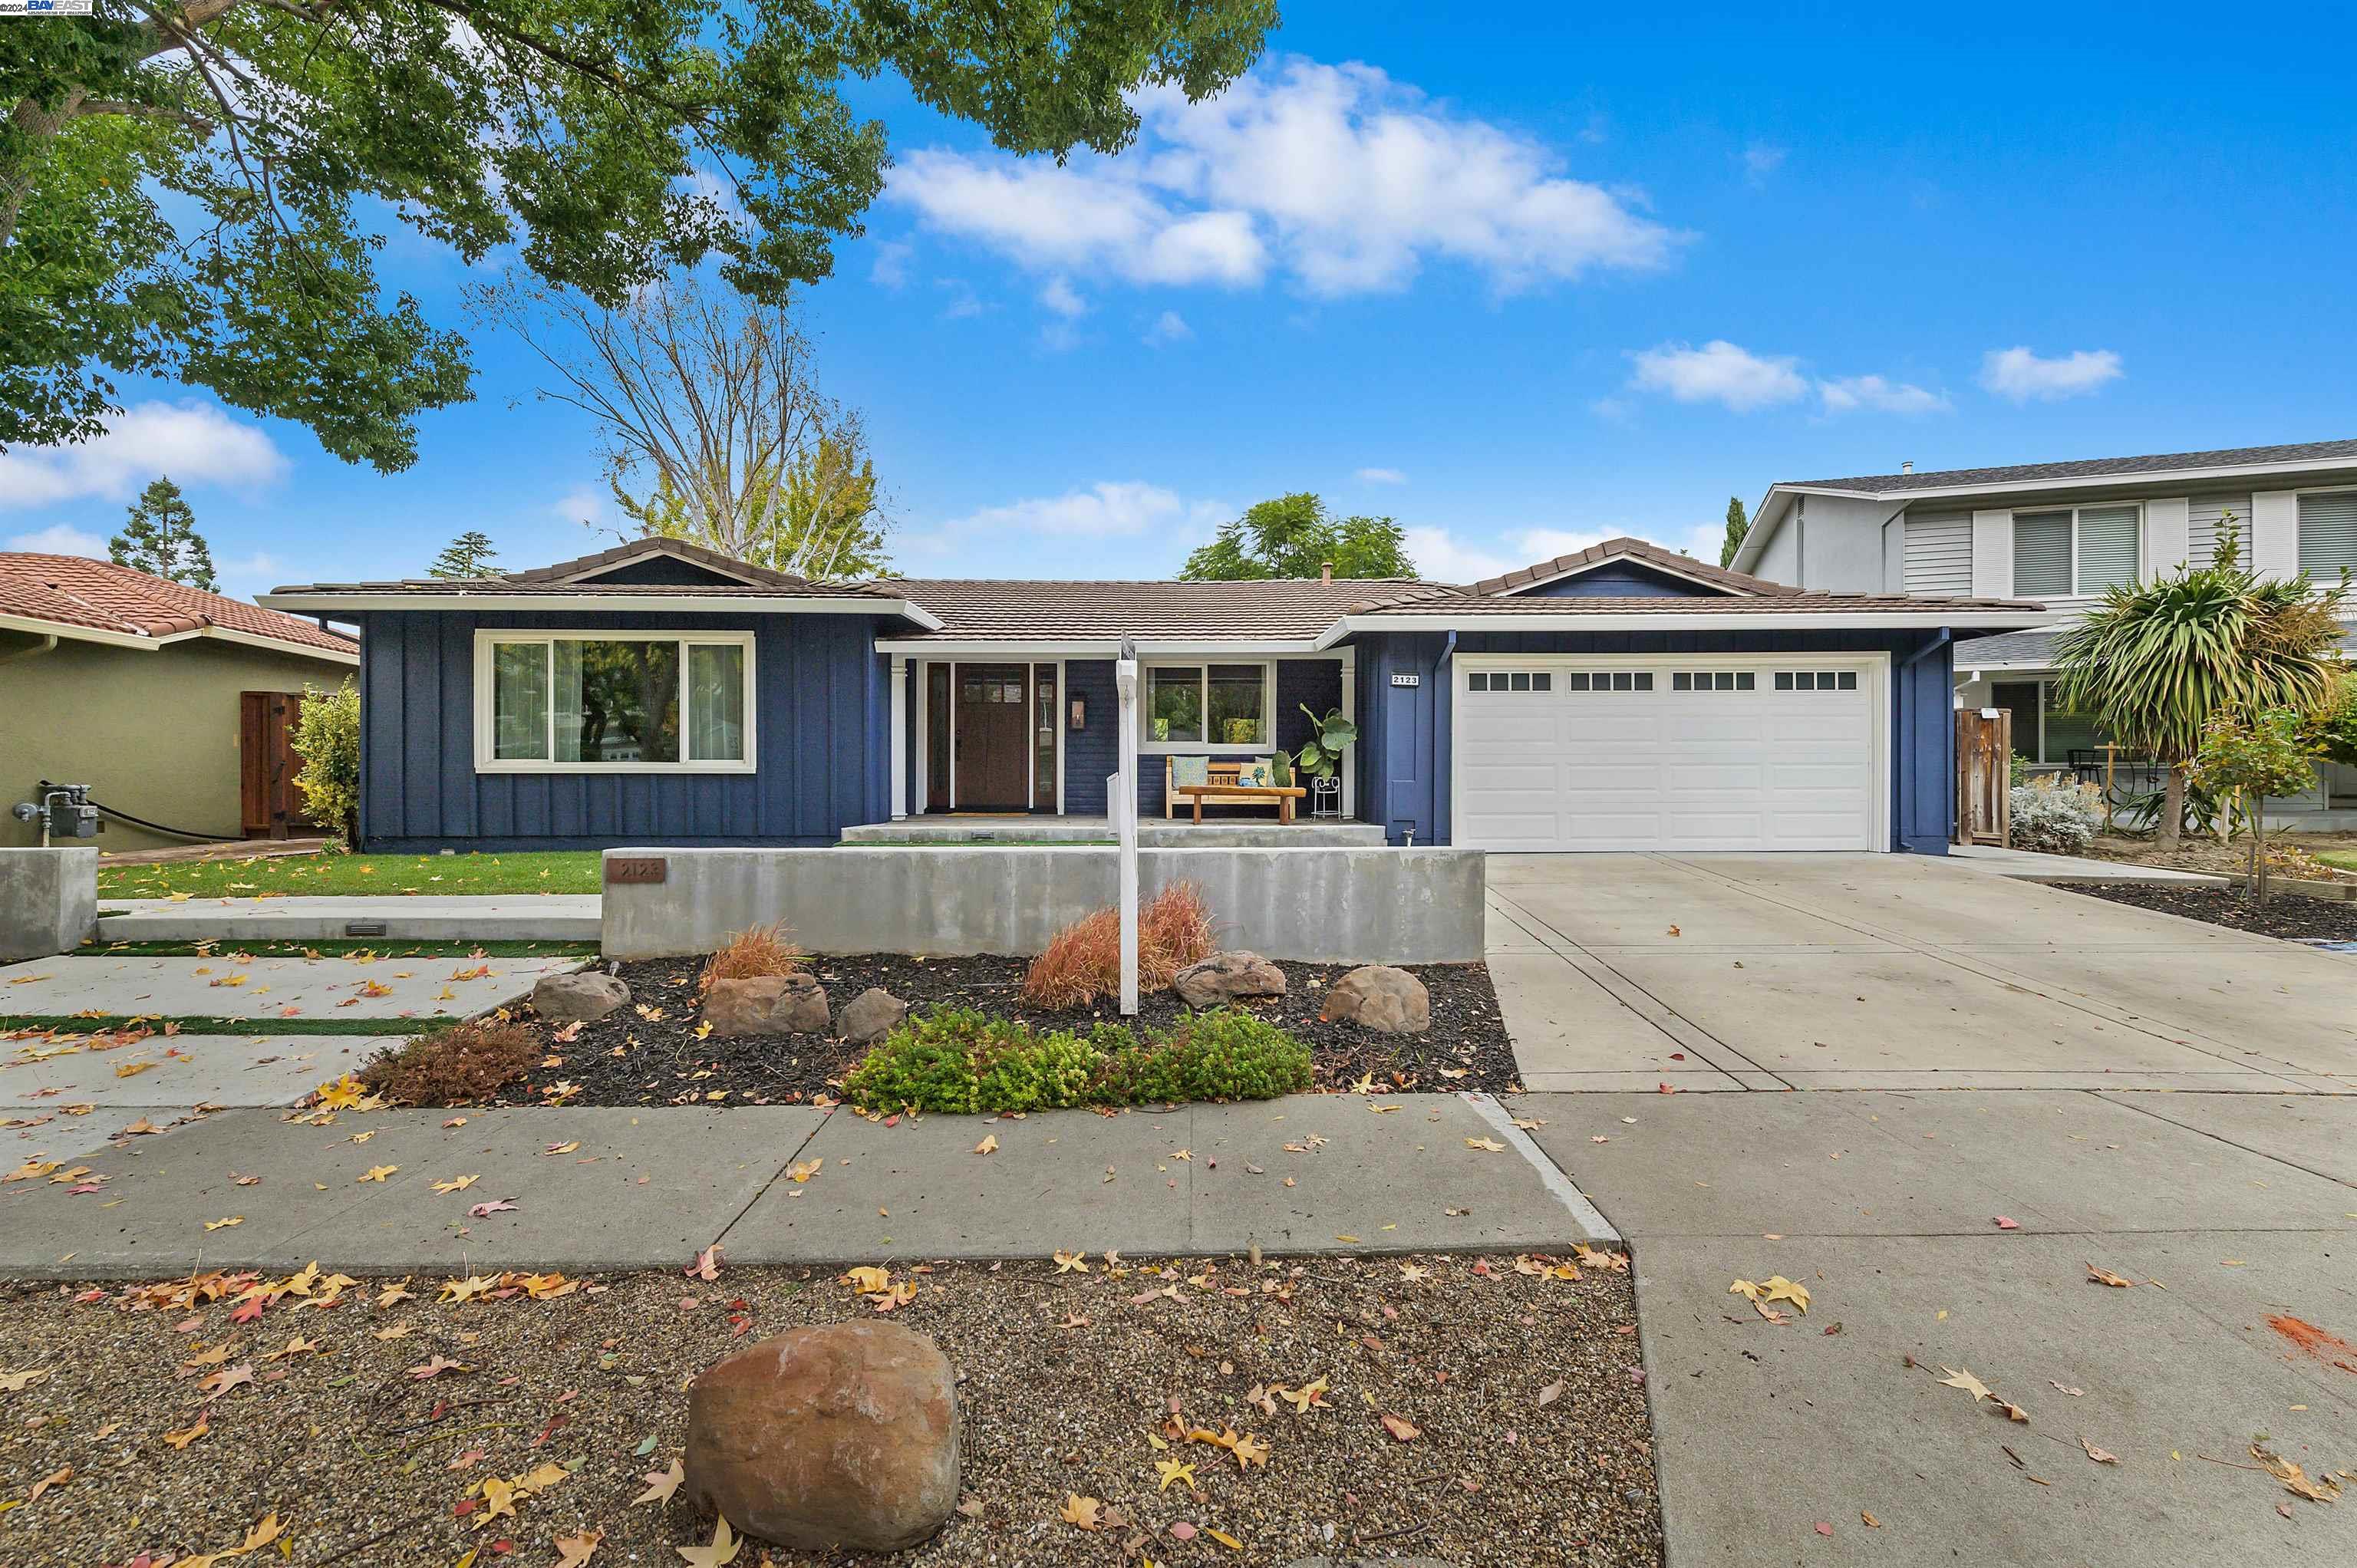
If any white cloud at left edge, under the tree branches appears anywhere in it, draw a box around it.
[0,401,288,507]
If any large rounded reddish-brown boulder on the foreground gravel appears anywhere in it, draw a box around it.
[684,1323,959,1551]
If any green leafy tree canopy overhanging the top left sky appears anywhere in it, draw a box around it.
[0,0,1277,472]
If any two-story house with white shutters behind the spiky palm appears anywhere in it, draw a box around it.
[1735,441,2357,828]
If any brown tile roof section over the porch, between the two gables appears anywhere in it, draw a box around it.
[886,578,1459,641]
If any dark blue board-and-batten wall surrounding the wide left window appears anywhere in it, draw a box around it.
[356,611,891,852]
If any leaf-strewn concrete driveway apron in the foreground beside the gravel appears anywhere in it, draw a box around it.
[1515,1092,2357,1568]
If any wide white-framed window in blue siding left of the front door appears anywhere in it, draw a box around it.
[476,632,752,773]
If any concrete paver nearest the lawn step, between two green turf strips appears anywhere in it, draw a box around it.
[0,953,582,1019]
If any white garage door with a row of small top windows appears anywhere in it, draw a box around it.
[1452,655,1888,852]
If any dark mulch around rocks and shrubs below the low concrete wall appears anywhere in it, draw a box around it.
[469,953,1515,1106]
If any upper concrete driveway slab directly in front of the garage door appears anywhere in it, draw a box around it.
[1487,854,2357,1094]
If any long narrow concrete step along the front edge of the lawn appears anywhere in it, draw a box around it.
[99,894,598,940]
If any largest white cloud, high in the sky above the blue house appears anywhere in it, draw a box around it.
[888,59,1680,295]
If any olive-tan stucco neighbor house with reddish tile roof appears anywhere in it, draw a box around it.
[0,554,361,854]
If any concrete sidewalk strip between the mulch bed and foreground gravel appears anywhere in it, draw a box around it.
[0,1094,1617,1278]
